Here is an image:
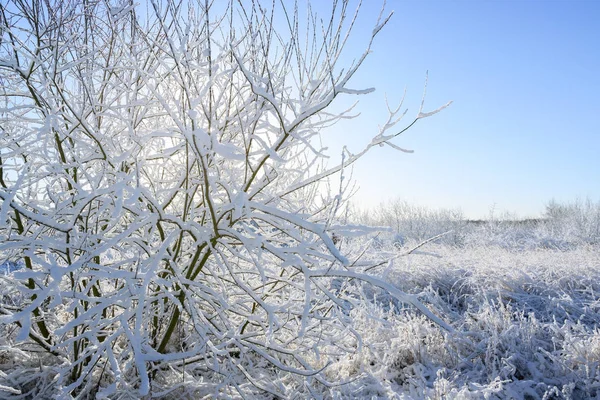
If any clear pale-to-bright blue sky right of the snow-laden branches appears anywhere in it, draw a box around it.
[316,0,600,218]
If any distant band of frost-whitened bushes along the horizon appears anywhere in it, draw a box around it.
[360,199,600,251]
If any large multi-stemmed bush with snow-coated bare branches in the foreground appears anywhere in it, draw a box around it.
[0,0,451,397]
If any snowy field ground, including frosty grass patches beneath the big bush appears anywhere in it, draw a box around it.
[0,208,600,399]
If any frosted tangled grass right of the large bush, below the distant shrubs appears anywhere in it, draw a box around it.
[330,246,600,399]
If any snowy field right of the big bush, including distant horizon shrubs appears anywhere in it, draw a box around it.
[334,201,600,399]
